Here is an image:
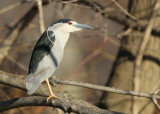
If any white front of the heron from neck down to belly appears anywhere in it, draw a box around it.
[34,33,69,82]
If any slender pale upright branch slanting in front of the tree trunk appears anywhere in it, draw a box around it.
[132,2,160,114]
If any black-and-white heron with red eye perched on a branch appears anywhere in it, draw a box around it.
[26,19,94,101]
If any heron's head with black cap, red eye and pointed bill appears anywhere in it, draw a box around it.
[52,19,93,33]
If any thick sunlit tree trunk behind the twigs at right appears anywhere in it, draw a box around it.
[106,0,160,114]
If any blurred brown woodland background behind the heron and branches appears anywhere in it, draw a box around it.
[0,0,160,114]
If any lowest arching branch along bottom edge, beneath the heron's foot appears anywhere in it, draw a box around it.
[0,95,122,114]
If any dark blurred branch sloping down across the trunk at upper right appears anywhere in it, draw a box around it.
[56,0,160,36]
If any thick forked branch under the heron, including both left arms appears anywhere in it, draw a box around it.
[0,71,123,114]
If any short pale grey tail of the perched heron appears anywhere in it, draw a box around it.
[26,75,41,95]
